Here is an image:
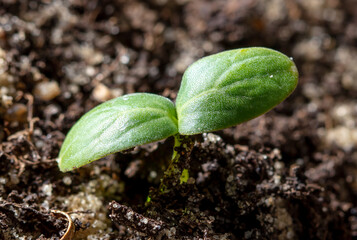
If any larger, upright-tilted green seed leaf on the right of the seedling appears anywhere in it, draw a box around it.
[176,47,298,135]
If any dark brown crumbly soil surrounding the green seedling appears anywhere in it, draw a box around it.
[0,0,357,239]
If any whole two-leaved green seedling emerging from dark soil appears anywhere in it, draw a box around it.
[58,47,298,172]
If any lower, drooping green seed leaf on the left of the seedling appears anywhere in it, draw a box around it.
[58,93,177,172]
